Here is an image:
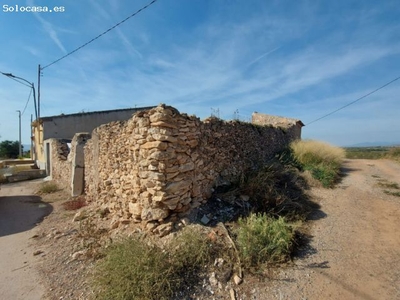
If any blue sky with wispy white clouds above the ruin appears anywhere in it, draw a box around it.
[0,0,400,146]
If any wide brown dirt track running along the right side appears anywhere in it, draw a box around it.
[262,160,400,300]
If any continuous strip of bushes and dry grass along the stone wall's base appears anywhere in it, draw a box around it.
[92,141,344,299]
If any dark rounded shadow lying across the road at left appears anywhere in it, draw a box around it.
[0,195,53,237]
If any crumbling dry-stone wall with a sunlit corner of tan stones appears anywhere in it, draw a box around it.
[84,105,300,230]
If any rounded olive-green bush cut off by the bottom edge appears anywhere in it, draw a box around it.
[95,238,175,300]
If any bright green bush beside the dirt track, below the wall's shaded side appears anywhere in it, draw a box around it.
[237,214,295,267]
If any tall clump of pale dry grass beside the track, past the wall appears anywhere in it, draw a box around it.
[290,140,345,188]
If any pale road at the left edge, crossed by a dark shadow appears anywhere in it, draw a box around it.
[0,181,51,300]
